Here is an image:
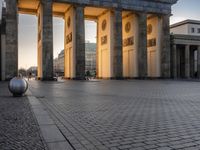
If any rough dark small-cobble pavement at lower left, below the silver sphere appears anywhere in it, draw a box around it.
[0,82,46,150]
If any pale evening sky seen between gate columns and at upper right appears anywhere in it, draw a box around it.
[0,0,200,69]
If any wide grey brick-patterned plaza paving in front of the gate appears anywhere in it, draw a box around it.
[31,80,200,150]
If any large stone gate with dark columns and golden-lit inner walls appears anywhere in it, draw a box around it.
[0,0,177,80]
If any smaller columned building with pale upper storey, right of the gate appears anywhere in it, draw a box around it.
[170,20,200,78]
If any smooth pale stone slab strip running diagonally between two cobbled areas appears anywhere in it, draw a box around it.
[27,90,73,150]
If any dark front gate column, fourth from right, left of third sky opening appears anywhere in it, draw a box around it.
[75,6,85,80]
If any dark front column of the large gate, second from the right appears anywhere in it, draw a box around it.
[138,13,147,78]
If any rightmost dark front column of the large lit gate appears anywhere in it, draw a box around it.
[160,15,170,78]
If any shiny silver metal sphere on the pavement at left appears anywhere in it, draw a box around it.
[8,77,28,96]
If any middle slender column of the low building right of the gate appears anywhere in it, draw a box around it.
[185,45,190,78]
